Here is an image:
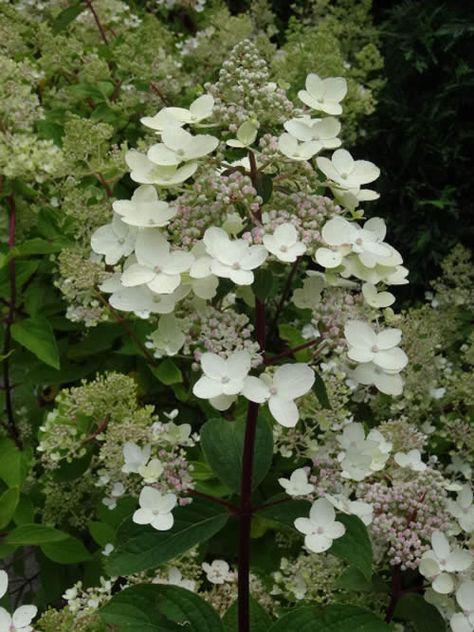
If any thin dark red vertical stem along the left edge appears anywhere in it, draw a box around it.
[2,194,21,448]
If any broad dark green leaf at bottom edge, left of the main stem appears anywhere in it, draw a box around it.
[99,584,224,632]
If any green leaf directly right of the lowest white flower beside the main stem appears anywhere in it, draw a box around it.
[330,514,373,581]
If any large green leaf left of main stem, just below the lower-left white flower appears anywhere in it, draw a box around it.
[107,498,229,575]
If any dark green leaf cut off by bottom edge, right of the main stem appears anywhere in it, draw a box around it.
[269,604,390,632]
